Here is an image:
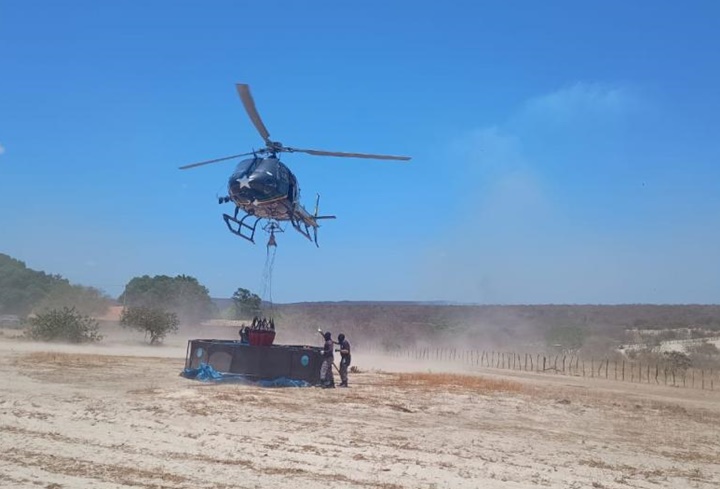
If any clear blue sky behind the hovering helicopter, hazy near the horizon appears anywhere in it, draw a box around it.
[0,0,720,304]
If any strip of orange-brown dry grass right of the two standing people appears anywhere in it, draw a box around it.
[393,373,527,393]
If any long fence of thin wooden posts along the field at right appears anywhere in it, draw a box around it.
[372,348,720,390]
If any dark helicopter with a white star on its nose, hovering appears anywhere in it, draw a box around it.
[180,83,411,247]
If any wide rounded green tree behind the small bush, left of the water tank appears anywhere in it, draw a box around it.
[119,275,215,323]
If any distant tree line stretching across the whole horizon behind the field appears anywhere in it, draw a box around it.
[5,250,720,361]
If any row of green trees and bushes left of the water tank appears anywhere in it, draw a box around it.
[0,254,262,344]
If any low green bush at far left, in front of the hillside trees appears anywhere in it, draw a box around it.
[25,307,102,343]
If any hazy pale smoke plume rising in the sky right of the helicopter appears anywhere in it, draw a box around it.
[418,83,639,302]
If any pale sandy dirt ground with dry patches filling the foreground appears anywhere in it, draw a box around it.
[0,324,720,489]
